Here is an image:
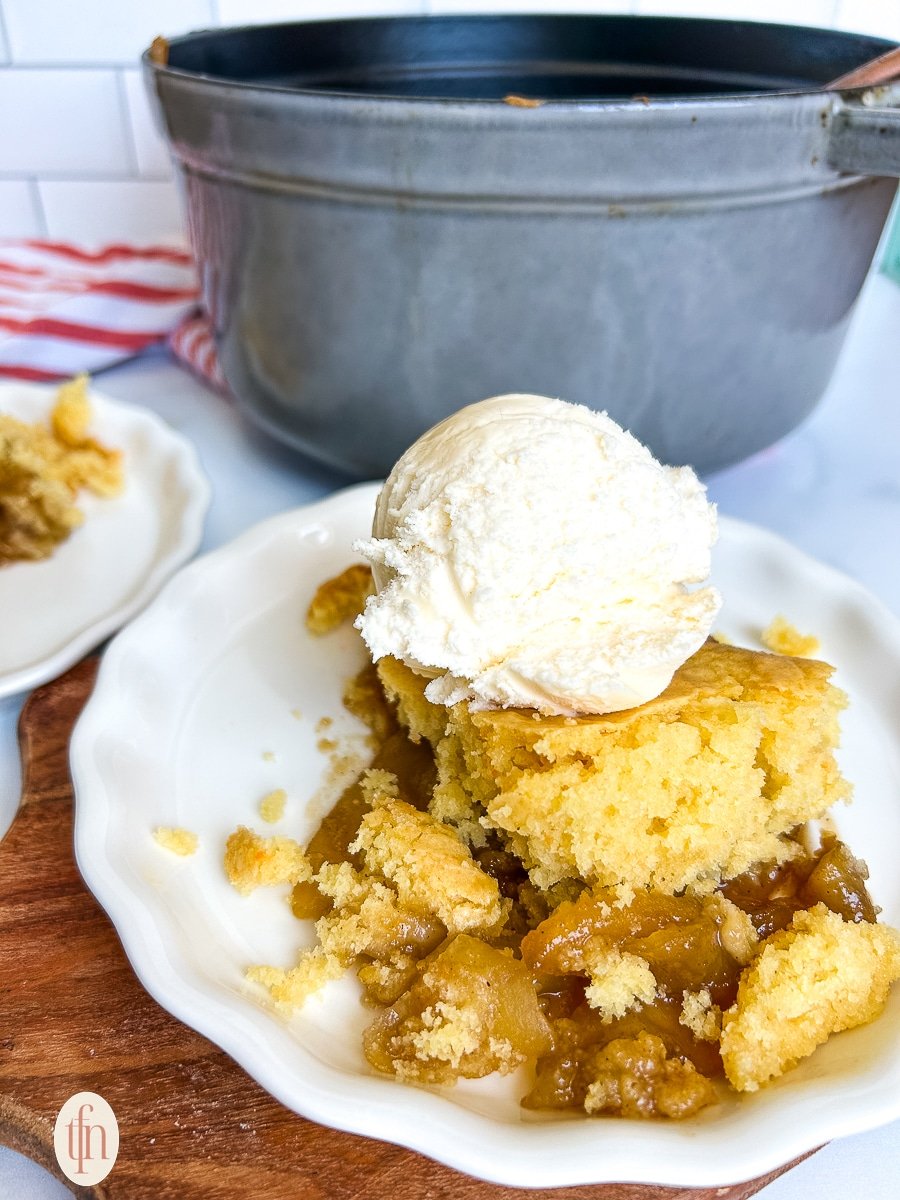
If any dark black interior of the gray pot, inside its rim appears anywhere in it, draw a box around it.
[168,14,890,102]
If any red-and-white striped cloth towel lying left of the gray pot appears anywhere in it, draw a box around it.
[0,240,204,383]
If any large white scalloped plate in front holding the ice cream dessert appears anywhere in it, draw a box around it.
[72,485,900,1187]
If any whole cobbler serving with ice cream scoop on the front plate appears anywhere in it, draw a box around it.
[226,396,900,1118]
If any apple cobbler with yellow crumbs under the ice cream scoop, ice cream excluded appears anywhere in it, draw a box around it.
[226,568,900,1118]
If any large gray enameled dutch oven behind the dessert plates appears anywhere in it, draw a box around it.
[145,16,900,476]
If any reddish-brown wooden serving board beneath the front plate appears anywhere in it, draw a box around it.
[0,659,816,1200]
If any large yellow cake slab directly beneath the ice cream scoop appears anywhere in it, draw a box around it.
[378,641,851,894]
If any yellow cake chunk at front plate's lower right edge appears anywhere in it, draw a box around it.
[721,904,900,1092]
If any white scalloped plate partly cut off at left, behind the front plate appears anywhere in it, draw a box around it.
[0,383,209,696]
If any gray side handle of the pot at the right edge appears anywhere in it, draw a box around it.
[828,85,900,178]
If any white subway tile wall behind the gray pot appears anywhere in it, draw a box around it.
[0,0,900,245]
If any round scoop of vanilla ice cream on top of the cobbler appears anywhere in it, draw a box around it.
[355,395,721,715]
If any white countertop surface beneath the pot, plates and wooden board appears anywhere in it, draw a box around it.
[0,276,900,1200]
